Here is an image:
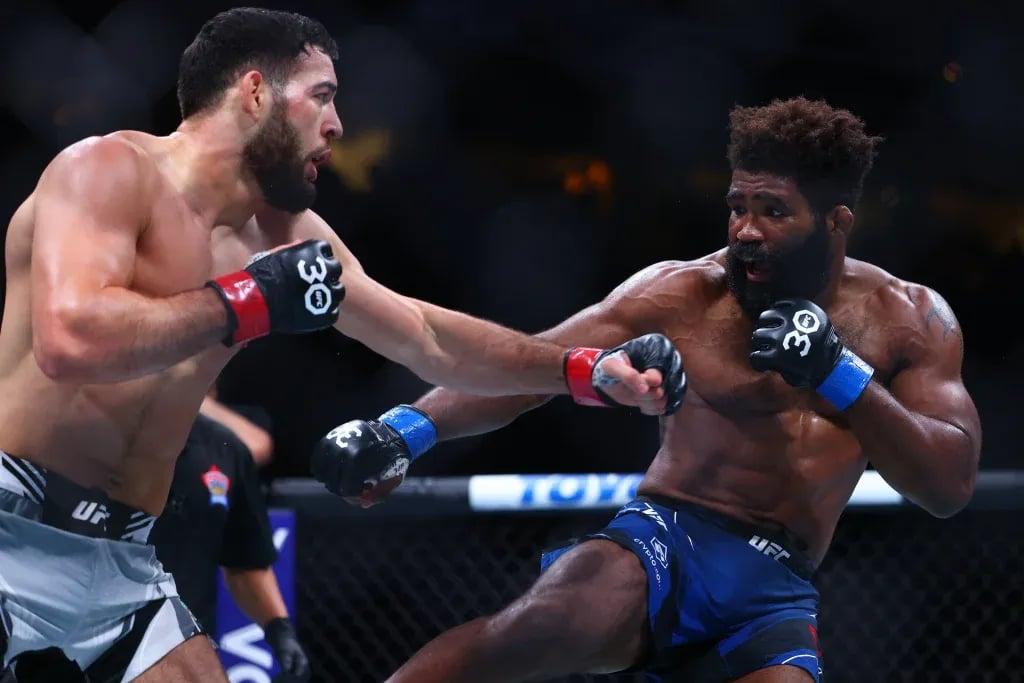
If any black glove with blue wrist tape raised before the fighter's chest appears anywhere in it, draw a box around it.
[751,299,874,411]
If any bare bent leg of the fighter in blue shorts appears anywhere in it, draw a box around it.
[388,540,648,683]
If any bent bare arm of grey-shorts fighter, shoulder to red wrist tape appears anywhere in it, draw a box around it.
[32,138,227,384]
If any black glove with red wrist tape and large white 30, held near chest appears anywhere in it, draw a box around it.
[206,240,345,346]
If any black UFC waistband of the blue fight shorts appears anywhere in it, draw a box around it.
[637,495,817,581]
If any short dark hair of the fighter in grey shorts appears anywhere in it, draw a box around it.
[178,7,338,119]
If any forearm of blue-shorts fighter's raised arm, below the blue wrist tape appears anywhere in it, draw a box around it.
[845,382,980,517]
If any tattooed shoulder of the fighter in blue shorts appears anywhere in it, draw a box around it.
[848,261,963,360]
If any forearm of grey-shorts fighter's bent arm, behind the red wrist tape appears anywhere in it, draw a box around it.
[34,287,228,384]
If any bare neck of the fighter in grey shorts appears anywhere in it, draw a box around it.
[169,112,264,228]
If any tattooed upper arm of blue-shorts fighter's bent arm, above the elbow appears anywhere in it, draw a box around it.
[890,292,981,450]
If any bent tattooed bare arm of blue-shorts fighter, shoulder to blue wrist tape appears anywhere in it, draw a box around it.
[847,288,981,517]
